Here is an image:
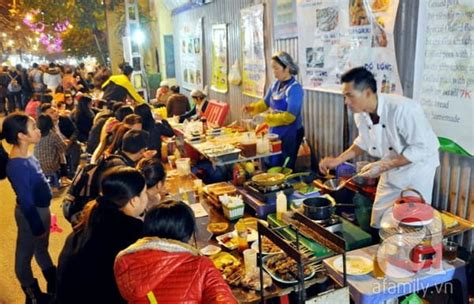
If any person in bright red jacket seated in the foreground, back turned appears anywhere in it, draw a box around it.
[114,201,237,304]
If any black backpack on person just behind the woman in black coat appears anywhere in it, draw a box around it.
[62,155,126,227]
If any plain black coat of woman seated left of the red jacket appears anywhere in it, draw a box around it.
[57,204,143,304]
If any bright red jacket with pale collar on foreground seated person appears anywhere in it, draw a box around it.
[114,237,237,304]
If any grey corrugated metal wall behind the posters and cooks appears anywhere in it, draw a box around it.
[173,0,474,250]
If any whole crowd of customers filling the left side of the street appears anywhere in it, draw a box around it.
[0,63,236,304]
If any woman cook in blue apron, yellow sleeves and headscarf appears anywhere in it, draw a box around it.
[244,52,304,169]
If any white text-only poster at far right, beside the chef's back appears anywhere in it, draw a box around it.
[413,0,474,156]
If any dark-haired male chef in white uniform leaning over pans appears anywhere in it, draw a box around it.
[319,67,439,228]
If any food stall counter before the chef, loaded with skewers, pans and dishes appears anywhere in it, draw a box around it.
[167,156,474,303]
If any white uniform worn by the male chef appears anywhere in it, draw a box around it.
[354,94,439,228]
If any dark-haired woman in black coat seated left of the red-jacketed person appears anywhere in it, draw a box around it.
[57,167,147,304]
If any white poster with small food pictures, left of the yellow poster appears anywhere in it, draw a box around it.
[179,18,203,90]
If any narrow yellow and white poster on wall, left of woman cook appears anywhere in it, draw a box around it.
[211,24,228,93]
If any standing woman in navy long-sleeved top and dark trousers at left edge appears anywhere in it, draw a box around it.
[1,113,56,303]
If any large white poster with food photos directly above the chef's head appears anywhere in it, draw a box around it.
[297,0,403,94]
